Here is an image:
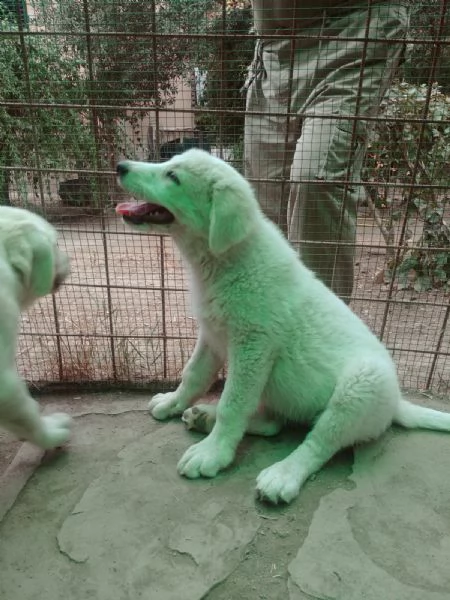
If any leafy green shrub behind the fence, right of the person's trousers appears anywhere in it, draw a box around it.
[364,82,450,291]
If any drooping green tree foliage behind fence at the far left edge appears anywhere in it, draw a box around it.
[0,4,94,203]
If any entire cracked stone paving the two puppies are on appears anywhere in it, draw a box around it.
[0,393,450,600]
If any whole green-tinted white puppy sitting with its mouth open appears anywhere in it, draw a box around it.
[116,150,450,503]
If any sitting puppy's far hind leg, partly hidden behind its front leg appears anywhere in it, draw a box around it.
[181,404,283,437]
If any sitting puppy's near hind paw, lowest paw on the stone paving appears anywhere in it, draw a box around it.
[256,460,301,504]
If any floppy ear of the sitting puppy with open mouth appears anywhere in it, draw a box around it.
[209,180,257,254]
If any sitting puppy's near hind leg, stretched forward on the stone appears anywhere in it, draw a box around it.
[256,364,398,504]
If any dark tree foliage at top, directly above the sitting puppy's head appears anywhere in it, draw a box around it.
[48,0,210,106]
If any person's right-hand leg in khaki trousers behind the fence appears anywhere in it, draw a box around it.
[288,5,407,302]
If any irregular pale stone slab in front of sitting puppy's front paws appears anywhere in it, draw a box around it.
[57,423,260,600]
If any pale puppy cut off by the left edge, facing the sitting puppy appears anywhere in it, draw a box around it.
[0,206,70,448]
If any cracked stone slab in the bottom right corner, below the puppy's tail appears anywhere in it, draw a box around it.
[289,430,450,600]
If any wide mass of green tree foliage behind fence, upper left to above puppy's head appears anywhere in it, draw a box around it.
[0,0,217,202]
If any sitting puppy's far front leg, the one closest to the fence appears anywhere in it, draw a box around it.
[148,336,223,420]
